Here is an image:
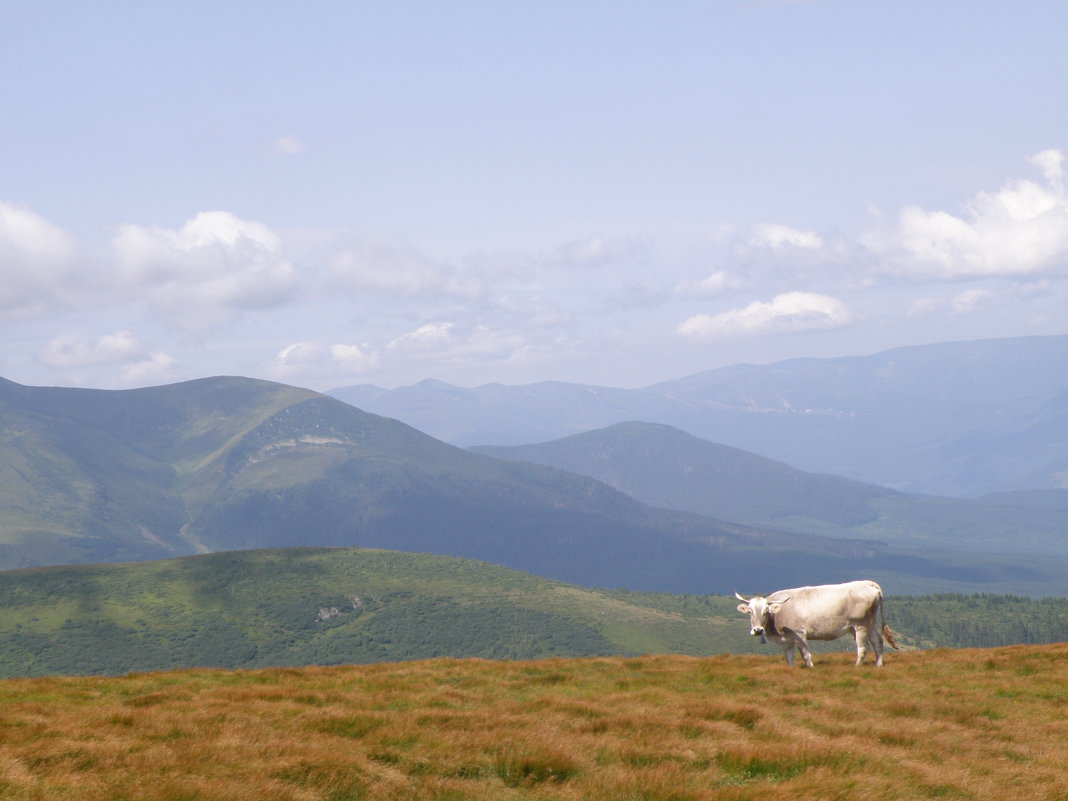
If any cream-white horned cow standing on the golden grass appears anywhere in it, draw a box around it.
[735,581,897,668]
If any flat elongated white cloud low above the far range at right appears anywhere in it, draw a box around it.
[678,292,853,337]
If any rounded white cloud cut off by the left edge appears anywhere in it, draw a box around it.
[0,202,78,311]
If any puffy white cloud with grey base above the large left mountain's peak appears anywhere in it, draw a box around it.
[112,211,298,330]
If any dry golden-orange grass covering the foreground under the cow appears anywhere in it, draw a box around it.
[0,644,1068,801]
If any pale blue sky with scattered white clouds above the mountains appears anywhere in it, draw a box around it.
[0,0,1068,391]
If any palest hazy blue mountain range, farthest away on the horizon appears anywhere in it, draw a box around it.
[331,336,1068,497]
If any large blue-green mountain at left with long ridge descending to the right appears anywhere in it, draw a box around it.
[0,378,1068,594]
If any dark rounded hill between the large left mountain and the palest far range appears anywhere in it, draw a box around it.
[471,423,1068,556]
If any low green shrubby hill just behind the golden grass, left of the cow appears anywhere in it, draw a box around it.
[0,548,752,676]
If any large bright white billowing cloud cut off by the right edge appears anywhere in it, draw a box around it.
[864,150,1068,279]
